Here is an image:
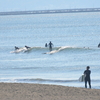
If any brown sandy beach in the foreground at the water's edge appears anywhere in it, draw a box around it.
[0,83,100,100]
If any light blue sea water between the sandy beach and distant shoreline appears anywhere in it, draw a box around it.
[0,12,100,89]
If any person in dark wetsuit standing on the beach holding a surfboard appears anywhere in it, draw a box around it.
[84,66,91,88]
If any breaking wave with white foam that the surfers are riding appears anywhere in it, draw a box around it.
[10,46,98,54]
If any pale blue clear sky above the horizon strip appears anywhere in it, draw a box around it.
[0,0,100,12]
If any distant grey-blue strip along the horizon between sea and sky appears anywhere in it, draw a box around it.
[0,8,100,16]
